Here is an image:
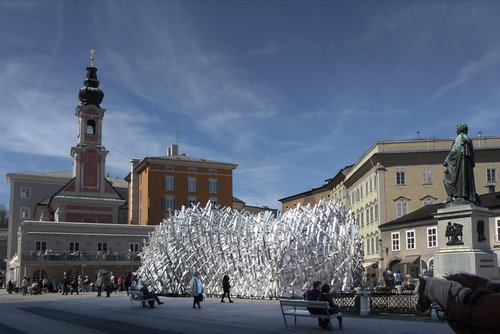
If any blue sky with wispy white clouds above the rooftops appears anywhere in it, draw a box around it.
[0,1,500,208]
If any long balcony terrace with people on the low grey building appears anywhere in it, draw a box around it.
[21,251,141,264]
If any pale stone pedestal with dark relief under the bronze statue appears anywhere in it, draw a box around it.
[434,201,498,279]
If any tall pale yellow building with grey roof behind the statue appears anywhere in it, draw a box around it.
[344,137,500,275]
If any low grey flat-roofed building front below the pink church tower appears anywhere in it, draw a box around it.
[13,220,154,286]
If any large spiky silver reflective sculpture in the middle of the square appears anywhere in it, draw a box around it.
[137,201,363,298]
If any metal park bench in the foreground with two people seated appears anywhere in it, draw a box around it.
[280,299,342,329]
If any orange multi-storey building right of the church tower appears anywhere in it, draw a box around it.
[125,145,238,225]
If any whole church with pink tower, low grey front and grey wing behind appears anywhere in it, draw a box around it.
[6,57,153,286]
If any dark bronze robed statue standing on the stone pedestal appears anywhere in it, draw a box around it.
[443,123,480,205]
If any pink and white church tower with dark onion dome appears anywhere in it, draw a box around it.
[48,50,126,224]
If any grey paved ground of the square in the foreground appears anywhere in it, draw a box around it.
[0,290,453,334]
